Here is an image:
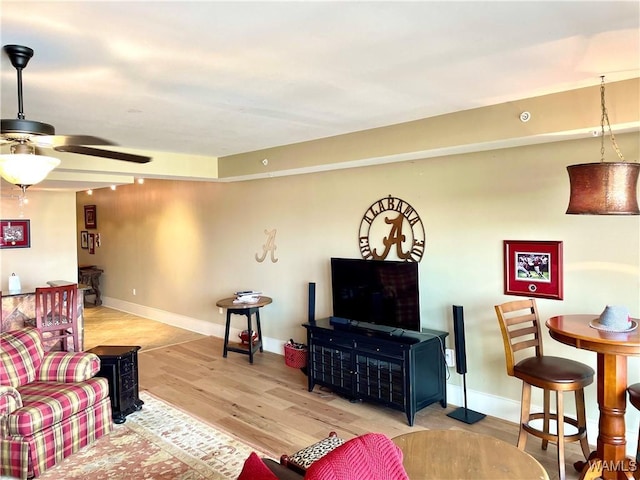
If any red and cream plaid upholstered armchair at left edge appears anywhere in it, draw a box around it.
[0,327,113,479]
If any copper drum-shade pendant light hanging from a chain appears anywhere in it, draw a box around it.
[566,76,640,215]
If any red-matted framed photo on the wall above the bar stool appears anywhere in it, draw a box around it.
[504,240,563,300]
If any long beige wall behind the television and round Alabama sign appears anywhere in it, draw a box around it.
[72,133,640,440]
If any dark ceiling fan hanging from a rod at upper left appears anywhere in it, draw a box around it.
[0,45,151,186]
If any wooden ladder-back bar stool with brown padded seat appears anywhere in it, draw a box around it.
[495,299,595,480]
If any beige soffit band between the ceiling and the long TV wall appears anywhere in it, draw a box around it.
[219,78,640,179]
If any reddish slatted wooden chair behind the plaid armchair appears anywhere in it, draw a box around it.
[36,283,82,351]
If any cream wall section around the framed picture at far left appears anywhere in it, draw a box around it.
[0,189,78,291]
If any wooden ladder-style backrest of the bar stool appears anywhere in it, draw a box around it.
[495,299,542,377]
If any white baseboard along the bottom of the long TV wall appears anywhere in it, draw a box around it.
[102,297,638,457]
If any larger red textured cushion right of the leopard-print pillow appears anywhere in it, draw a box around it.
[304,433,409,480]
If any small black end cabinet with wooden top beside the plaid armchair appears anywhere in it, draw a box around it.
[87,345,144,423]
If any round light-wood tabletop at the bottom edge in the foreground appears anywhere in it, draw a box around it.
[392,430,549,480]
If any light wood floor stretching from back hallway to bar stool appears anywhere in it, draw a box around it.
[85,307,595,480]
